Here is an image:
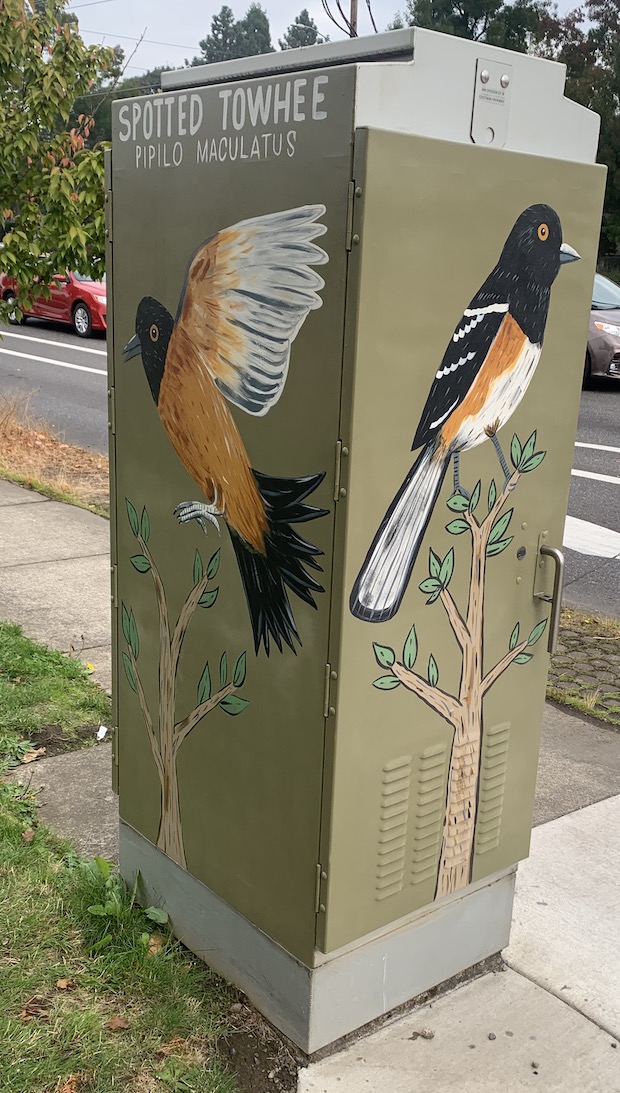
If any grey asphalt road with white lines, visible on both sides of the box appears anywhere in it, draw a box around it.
[0,319,620,618]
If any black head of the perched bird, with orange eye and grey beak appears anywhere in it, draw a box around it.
[499,204,580,291]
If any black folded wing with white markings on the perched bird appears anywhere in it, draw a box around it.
[411,286,507,449]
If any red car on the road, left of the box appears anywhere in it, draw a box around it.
[0,270,106,338]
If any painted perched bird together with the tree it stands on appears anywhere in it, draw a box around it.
[350,204,580,897]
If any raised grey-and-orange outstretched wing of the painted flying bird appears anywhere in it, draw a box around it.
[176,204,328,416]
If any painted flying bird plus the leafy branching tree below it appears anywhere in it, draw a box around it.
[121,204,328,865]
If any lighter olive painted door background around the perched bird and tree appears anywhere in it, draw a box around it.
[319,125,605,951]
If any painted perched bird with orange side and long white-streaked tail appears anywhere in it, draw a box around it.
[350,204,580,622]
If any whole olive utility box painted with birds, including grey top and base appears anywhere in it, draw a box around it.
[107,30,605,1053]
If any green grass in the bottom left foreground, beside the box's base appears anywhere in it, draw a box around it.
[0,808,235,1093]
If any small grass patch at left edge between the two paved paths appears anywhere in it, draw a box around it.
[0,622,110,771]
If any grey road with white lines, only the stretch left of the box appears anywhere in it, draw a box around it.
[0,319,107,451]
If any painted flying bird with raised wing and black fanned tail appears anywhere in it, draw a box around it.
[124,204,327,656]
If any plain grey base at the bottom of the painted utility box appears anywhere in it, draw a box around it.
[120,822,516,1055]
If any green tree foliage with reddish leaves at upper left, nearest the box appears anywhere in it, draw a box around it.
[0,0,114,308]
